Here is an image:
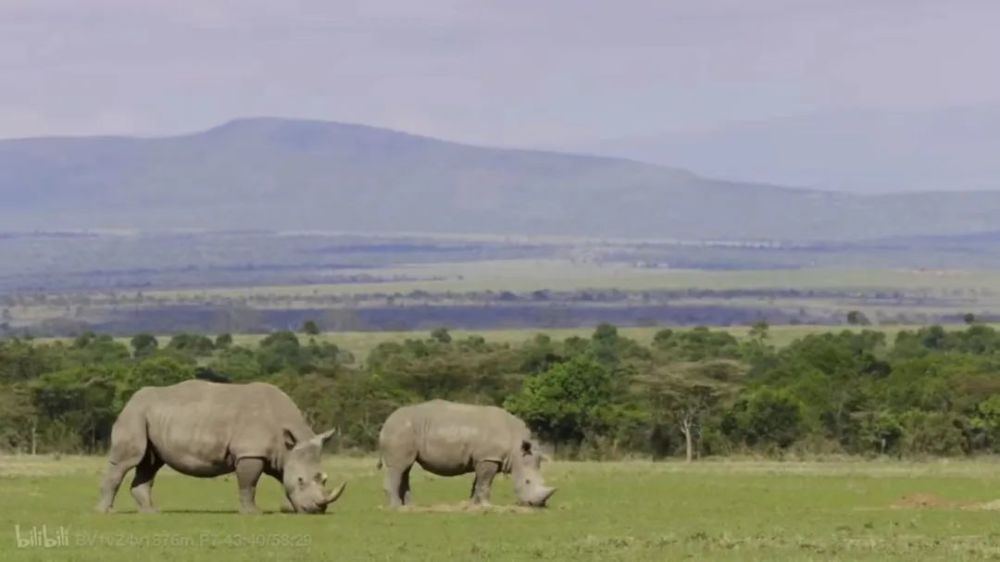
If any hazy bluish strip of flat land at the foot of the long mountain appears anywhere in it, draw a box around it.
[0,230,1000,294]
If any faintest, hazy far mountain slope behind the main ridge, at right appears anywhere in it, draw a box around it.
[573,106,1000,193]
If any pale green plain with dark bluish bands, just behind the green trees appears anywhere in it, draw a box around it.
[7,259,1000,336]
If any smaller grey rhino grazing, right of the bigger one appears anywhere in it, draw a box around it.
[379,400,556,507]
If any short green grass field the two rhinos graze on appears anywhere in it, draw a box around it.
[0,457,1000,562]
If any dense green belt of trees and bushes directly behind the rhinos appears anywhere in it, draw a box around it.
[0,322,1000,458]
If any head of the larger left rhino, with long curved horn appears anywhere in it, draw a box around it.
[281,429,347,513]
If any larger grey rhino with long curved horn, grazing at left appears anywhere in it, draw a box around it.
[97,380,346,513]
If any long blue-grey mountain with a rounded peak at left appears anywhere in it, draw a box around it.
[0,118,1000,240]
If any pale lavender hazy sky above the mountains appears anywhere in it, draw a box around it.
[0,0,1000,146]
